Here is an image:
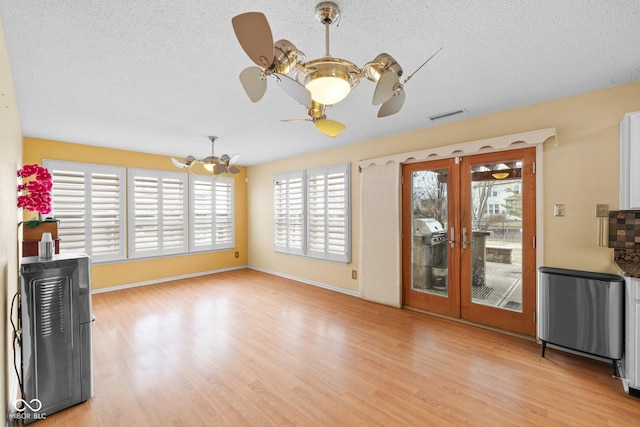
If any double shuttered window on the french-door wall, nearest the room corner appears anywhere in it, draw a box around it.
[273,163,351,263]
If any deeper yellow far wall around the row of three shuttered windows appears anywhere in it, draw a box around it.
[24,138,247,290]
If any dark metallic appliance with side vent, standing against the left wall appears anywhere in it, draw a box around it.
[20,254,93,423]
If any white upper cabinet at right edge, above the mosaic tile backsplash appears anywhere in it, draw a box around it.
[620,111,640,210]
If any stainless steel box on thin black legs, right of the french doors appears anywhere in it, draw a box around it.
[538,267,624,371]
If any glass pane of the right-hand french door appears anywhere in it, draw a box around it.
[470,160,523,312]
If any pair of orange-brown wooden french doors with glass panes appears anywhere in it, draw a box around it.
[402,148,536,335]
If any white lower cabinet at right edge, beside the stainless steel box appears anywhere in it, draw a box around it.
[622,277,640,397]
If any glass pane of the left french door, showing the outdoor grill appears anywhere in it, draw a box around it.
[411,169,449,297]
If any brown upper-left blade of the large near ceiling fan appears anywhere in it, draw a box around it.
[231,12,275,68]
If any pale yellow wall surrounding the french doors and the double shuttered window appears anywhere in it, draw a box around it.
[247,82,640,291]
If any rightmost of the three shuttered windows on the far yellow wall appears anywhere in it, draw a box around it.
[189,175,235,251]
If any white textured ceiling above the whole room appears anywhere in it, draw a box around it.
[0,0,640,165]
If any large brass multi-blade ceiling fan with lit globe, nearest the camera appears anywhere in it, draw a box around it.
[231,2,442,137]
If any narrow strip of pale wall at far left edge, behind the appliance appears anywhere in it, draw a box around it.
[0,15,22,423]
